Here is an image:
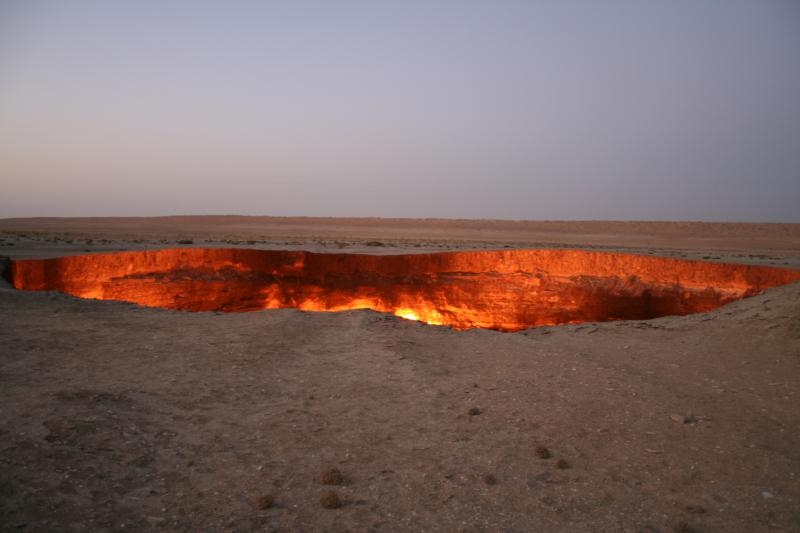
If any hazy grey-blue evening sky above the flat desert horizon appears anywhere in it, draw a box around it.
[0,0,800,222]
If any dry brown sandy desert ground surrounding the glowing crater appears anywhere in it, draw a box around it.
[0,217,800,532]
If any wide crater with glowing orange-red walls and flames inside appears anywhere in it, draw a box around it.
[9,248,800,331]
